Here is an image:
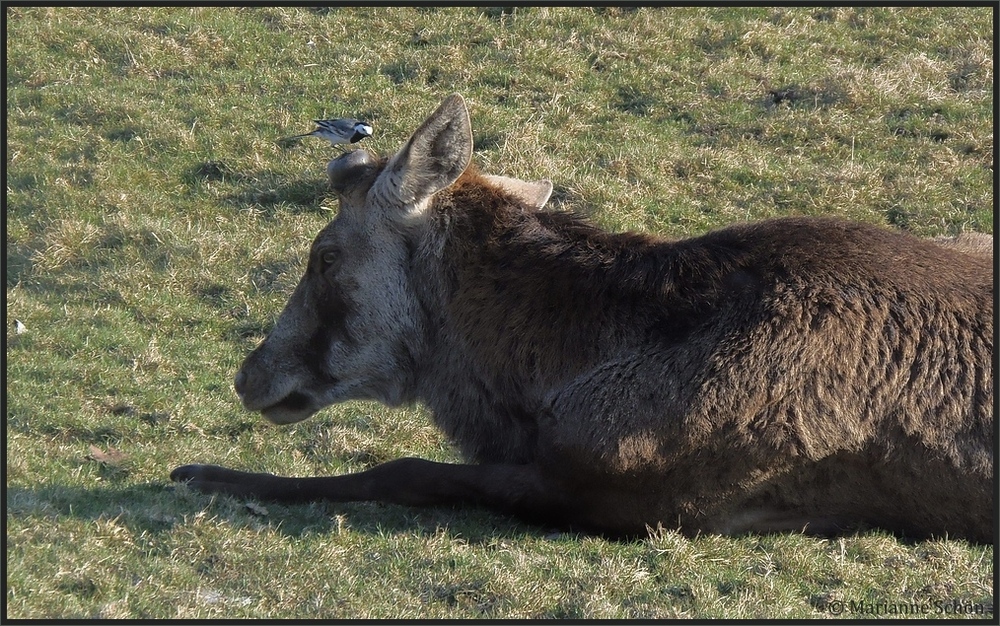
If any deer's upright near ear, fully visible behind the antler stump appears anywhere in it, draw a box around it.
[376,93,472,209]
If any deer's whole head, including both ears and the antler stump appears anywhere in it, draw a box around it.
[236,96,540,423]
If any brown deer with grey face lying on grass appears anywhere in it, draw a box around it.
[171,94,995,542]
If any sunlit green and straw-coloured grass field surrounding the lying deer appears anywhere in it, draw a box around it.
[5,7,995,619]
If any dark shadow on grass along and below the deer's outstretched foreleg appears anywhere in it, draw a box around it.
[6,472,550,544]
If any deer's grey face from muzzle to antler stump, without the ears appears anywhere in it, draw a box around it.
[236,153,423,423]
